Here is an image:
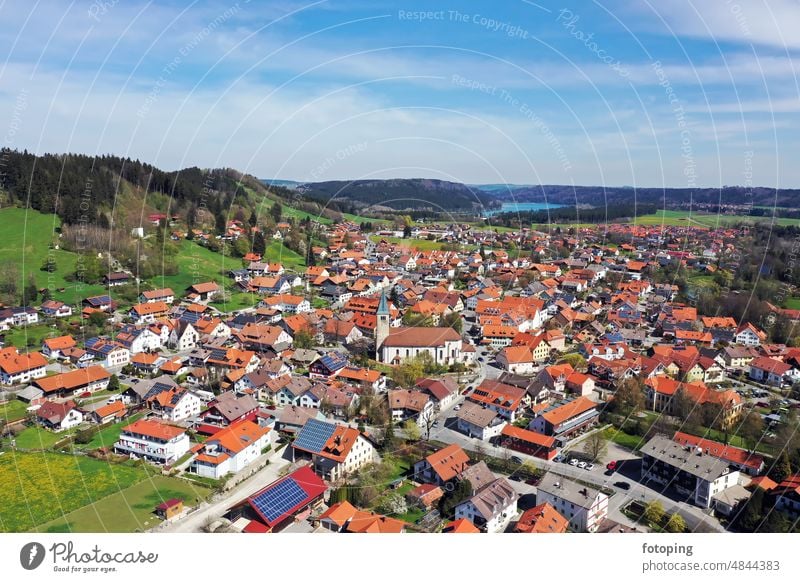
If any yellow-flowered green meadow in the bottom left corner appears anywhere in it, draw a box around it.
[0,451,147,532]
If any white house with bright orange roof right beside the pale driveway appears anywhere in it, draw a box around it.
[189,420,274,479]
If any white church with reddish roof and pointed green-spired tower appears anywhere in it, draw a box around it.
[375,293,469,366]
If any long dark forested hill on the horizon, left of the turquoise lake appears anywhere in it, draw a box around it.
[297,178,496,213]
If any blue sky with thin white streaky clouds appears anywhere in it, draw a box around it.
[0,0,800,187]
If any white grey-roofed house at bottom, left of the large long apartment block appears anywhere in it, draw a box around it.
[536,473,608,533]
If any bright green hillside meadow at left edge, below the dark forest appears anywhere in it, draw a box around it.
[0,208,105,304]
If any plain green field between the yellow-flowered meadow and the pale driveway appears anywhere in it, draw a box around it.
[36,475,210,533]
